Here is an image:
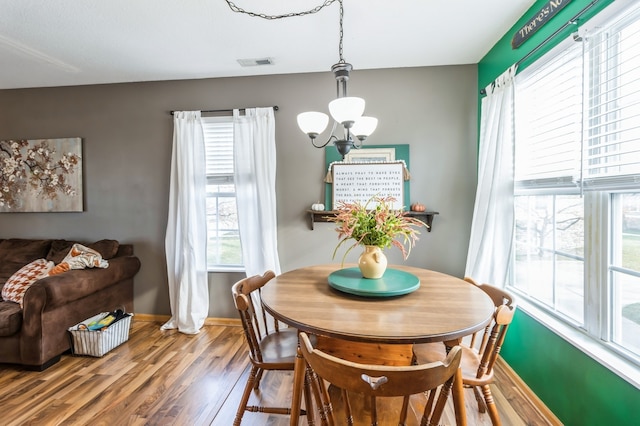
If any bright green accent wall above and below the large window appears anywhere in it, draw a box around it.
[478,0,640,426]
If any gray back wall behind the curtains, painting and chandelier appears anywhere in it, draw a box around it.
[0,65,478,317]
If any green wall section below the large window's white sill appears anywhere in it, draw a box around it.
[502,311,640,426]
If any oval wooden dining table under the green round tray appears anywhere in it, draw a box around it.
[262,264,494,425]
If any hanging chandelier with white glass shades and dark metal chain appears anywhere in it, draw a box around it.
[297,0,378,159]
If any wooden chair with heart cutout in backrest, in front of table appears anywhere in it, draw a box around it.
[300,332,462,426]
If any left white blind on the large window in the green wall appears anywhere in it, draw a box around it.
[515,43,582,189]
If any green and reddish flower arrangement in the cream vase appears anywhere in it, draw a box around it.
[329,196,428,263]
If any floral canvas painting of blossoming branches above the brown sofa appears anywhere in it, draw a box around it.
[0,138,83,212]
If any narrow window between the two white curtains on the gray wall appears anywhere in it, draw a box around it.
[202,117,244,271]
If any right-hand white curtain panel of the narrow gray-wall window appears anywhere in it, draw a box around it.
[233,108,280,277]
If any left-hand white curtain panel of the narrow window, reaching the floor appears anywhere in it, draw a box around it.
[161,111,209,334]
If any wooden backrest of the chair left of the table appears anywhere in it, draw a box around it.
[231,271,278,362]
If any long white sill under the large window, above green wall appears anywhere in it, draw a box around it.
[518,298,640,389]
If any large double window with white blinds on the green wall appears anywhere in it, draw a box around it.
[511,0,640,365]
